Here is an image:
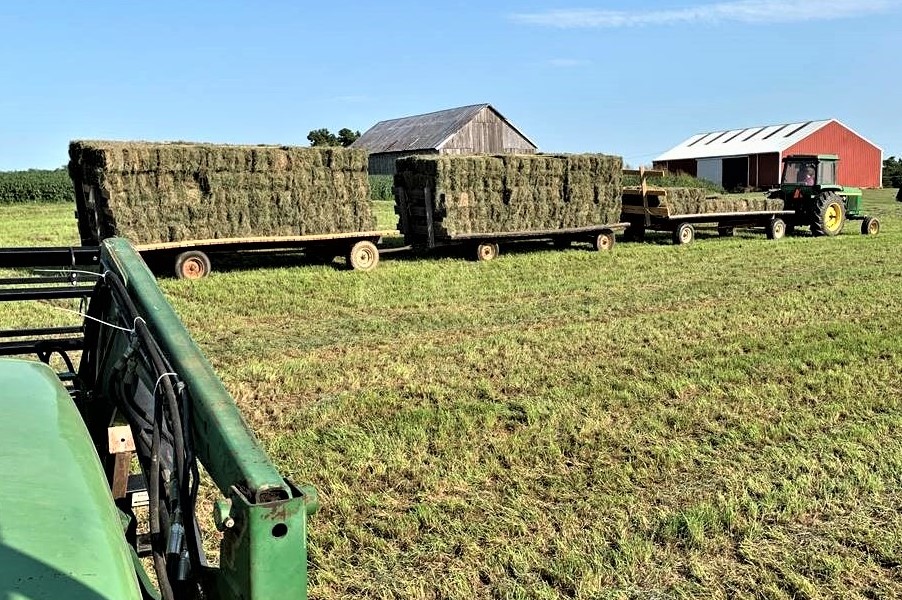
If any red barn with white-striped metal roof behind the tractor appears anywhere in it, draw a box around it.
[654,119,883,190]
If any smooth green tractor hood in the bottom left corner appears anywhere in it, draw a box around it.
[0,359,141,600]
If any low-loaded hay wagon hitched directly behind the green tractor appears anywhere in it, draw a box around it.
[621,169,795,244]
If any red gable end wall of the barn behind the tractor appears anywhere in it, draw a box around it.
[783,121,883,188]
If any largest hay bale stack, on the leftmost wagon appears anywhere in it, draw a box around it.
[69,141,375,244]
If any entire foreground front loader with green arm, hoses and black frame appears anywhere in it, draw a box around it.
[0,238,318,600]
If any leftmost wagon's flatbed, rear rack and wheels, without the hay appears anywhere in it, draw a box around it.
[75,178,396,279]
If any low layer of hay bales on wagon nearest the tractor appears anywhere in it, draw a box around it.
[623,188,783,215]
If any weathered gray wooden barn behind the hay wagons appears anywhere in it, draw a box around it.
[351,104,537,175]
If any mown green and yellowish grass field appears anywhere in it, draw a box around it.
[0,190,902,600]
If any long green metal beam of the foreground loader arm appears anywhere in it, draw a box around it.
[102,238,318,600]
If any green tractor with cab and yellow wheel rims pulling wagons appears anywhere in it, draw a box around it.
[768,154,880,236]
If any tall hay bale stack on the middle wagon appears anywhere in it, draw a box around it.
[395,154,623,243]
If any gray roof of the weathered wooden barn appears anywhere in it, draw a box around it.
[351,104,535,154]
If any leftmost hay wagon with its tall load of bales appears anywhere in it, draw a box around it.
[69,141,393,279]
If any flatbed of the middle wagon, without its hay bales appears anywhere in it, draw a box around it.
[396,187,629,261]
